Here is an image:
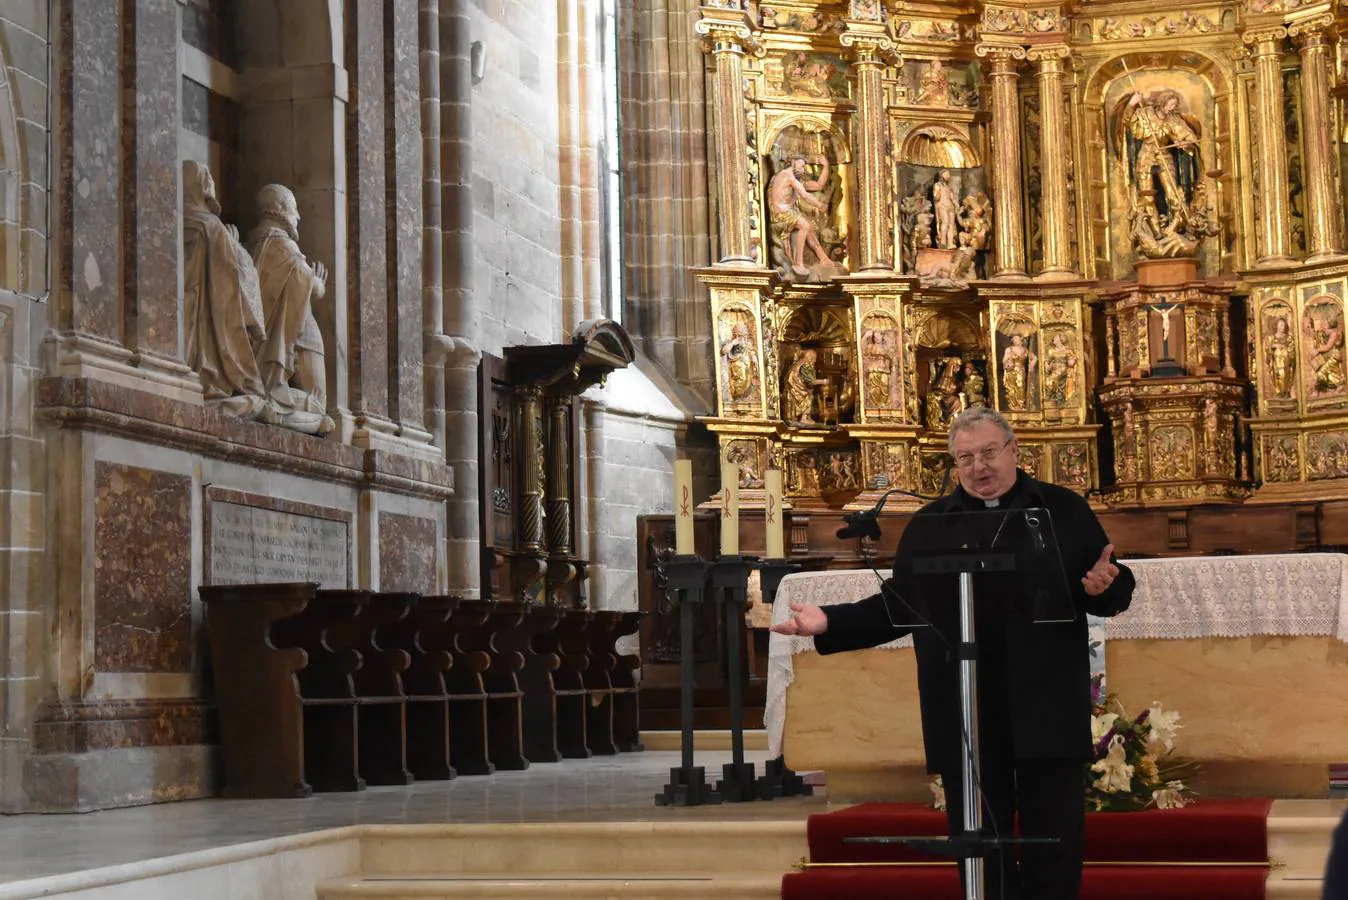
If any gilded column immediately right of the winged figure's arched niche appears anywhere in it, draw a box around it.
[1242,26,1289,265]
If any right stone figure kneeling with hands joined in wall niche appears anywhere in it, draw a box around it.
[248,185,333,434]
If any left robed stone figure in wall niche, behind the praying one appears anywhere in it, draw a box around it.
[182,159,276,422]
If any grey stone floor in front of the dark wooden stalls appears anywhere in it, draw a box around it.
[0,750,824,884]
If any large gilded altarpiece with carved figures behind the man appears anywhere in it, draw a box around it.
[697,0,1348,509]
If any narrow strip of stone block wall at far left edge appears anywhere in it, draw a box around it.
[0,0,51,810]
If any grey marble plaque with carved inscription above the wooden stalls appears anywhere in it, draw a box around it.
[210,501,350,587]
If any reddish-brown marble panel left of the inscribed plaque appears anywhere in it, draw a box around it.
[93,462,193,672]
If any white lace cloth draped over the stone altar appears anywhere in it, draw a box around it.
[763,554,1348,756]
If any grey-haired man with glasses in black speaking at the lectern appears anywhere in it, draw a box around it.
[772,407,1134,900]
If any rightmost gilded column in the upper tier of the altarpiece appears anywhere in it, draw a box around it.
[1287,15,1343,260]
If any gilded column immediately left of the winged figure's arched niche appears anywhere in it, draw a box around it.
[1030,44,1076,280]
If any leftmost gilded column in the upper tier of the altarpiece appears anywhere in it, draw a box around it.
[696,8,758,265]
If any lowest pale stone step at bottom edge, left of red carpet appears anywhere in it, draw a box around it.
[318,872,782,900]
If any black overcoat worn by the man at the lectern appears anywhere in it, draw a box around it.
[814,472,1134,772]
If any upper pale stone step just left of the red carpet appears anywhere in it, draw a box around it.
[360,819,809,873]
